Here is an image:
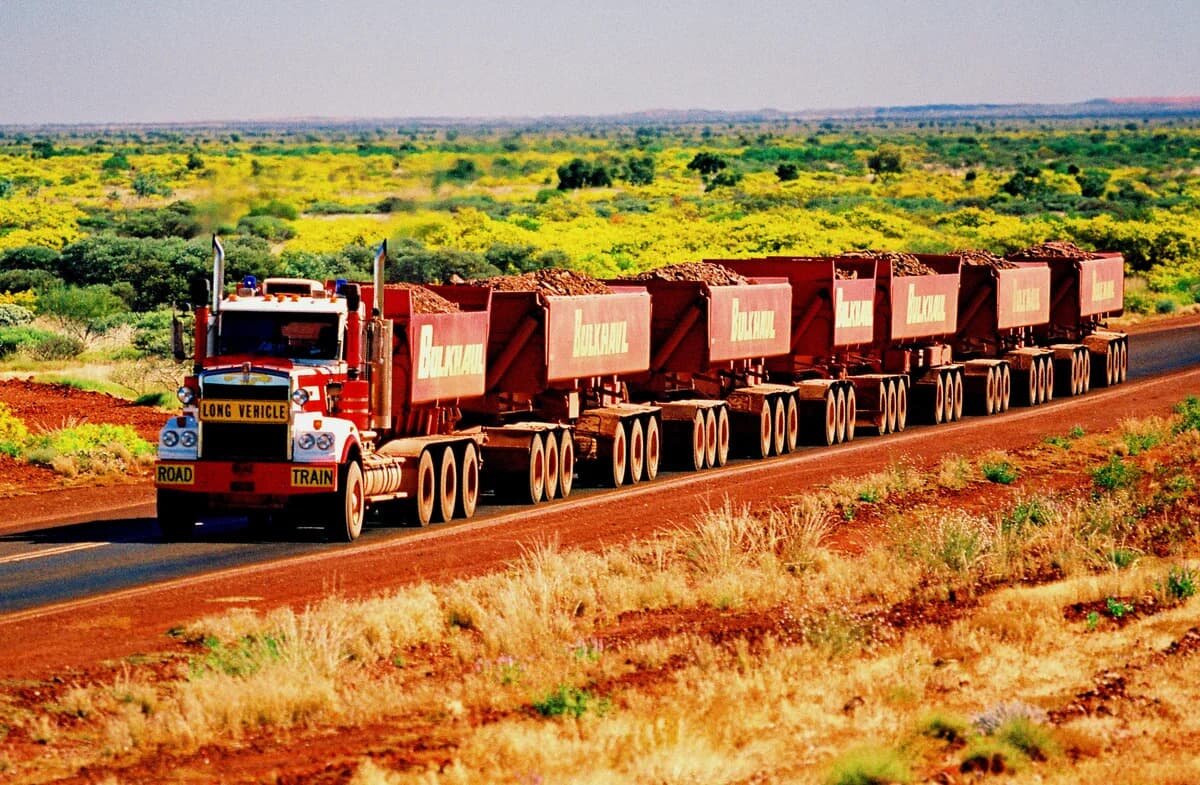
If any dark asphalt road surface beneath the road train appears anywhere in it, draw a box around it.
[0,326,1200,615]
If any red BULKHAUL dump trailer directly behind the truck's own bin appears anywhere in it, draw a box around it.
[430,283,662,503]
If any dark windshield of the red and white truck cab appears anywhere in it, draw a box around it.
[220,311,338,360]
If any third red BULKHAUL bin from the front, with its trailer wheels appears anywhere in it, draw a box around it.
[608,277,799,471]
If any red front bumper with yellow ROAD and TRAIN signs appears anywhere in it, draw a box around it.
[155,460,337,504]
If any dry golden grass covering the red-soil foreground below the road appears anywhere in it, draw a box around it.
[7,403,1200,783]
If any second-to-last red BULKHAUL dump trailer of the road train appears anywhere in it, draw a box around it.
[945,256,1051,415]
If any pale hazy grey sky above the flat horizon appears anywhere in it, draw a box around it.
[0,0,1200,124]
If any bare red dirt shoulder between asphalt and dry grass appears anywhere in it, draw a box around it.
[0,370,1200,678]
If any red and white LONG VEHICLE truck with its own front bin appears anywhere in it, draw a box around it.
[155,238,490,540]
